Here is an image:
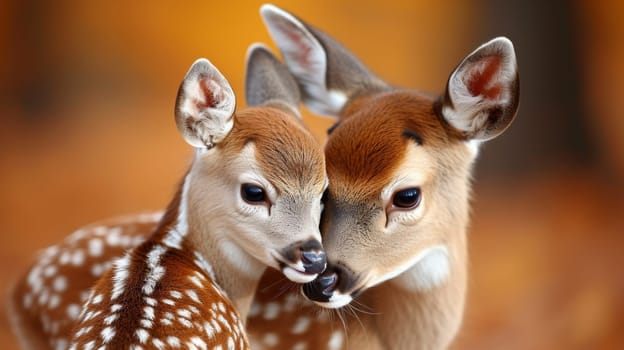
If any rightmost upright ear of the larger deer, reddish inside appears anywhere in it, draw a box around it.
[442,37,520,141]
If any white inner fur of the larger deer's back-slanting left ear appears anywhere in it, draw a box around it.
[260,4,347,115]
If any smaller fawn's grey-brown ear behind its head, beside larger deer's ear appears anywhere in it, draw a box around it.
[245,43,301,119]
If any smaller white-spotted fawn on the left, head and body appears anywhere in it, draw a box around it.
[8,45,327,349]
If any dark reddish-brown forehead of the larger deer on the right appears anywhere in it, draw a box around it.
[325,92,450,198]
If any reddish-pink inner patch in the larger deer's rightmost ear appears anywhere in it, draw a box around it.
[466,56,503,99]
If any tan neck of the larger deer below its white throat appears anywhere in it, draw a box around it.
[363,228,467,349]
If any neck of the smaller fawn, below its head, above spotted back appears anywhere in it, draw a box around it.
[153,170,265,320]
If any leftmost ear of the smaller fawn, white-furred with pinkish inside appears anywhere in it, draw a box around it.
[175,58,236,149]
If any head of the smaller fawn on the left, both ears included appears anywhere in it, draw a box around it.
[175,45,326,282]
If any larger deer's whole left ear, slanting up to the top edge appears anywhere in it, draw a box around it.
[260,5,388,116]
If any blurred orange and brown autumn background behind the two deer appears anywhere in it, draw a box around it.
[0,0,624,349]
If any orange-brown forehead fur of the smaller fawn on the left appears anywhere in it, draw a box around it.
[224,107,325,193]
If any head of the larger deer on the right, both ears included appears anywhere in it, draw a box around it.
[261,5,518,307]
